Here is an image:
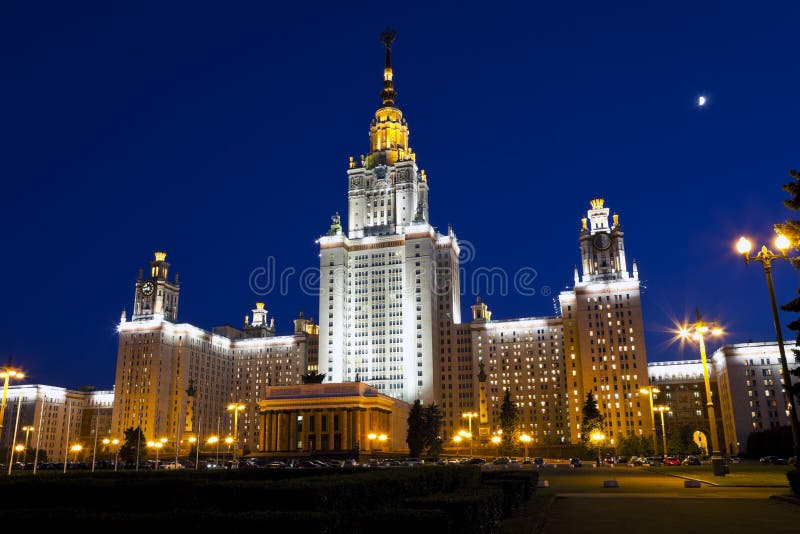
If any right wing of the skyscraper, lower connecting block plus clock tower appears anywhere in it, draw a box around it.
[437,199,652,445]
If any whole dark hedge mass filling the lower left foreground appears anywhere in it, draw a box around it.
[0,466,538,534]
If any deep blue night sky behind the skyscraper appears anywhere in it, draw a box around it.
[0,1,800,387]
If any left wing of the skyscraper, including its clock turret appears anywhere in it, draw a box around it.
[112,252,318,451]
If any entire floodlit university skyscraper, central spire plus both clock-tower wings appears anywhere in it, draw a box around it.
[112,36,652,451]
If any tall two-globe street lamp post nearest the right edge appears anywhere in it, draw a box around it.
[736,235,800,469]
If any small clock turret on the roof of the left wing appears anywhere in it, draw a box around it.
[131,252,180,322]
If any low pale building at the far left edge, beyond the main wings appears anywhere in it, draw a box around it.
[2,385,114,462]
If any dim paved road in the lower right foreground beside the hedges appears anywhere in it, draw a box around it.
[502,467,800,534]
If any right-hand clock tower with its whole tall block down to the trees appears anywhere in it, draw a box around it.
[558,198,653,445]
